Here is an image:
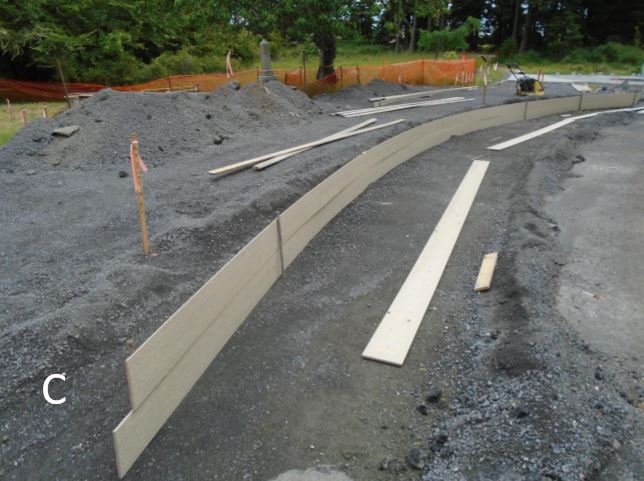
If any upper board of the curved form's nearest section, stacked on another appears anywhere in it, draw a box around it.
[125,221,279,410]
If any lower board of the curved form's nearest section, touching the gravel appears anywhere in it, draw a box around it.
[112,249,281,478]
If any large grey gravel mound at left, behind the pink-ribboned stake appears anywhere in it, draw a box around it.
[0,81,320,169]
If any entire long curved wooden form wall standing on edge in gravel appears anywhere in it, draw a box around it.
[112,92,640,478]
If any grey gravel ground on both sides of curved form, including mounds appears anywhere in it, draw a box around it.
[0,83,642,481]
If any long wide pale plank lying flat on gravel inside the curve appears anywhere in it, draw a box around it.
[362,160,489,366]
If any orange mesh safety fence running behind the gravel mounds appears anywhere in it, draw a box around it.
[0,58,476,101]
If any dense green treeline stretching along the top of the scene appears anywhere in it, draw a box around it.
[0,0,644,84]
